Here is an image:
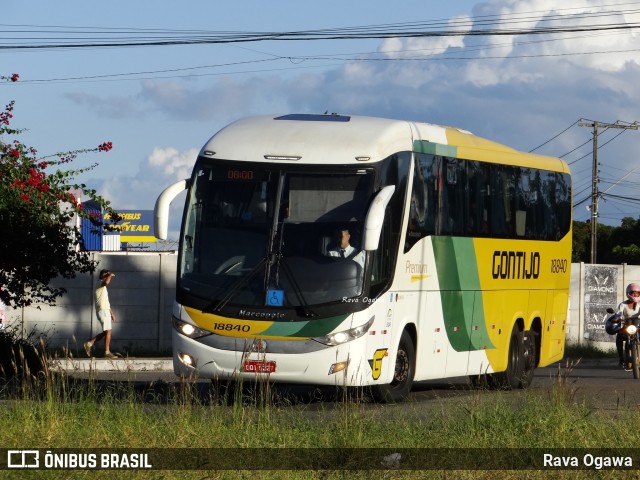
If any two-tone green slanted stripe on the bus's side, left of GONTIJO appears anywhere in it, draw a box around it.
[432,237,493,352]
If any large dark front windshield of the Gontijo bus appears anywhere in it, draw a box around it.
[178,159,374,311]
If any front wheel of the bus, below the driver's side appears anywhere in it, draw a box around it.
[372,331,416,403]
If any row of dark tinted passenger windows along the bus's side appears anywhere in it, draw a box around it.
[404,154,571,244]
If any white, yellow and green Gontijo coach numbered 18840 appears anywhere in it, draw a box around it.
[155,114,571,402]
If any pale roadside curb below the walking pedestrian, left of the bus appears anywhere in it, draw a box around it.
[51,357,173,372]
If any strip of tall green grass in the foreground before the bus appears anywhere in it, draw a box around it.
[0,363,640,480]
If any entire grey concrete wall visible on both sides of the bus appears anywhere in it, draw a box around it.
[7,258,640,353]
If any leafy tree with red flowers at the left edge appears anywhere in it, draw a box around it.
[0,74,119,307]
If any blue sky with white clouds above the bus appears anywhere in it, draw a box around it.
[0,0,640,236]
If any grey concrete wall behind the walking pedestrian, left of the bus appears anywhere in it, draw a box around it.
[7,252,177,353]
